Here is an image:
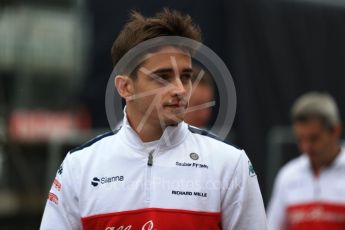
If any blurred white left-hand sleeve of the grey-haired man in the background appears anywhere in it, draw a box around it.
[267,169,286,230]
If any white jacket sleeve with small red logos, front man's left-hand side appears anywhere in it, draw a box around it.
[40,154,82,230]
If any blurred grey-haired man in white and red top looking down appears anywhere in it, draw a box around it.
[268,93,345,230]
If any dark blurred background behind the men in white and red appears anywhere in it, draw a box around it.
[0,0,345,229]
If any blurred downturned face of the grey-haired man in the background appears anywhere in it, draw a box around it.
[294,119,338,163]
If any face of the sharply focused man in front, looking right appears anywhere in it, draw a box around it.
[130,46,192,127]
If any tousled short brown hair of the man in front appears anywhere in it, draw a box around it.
[111,8,202,76]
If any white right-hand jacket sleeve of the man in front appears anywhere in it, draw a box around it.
[222,152,267,230]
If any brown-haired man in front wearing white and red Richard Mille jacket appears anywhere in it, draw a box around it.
[41,10,265,230]
